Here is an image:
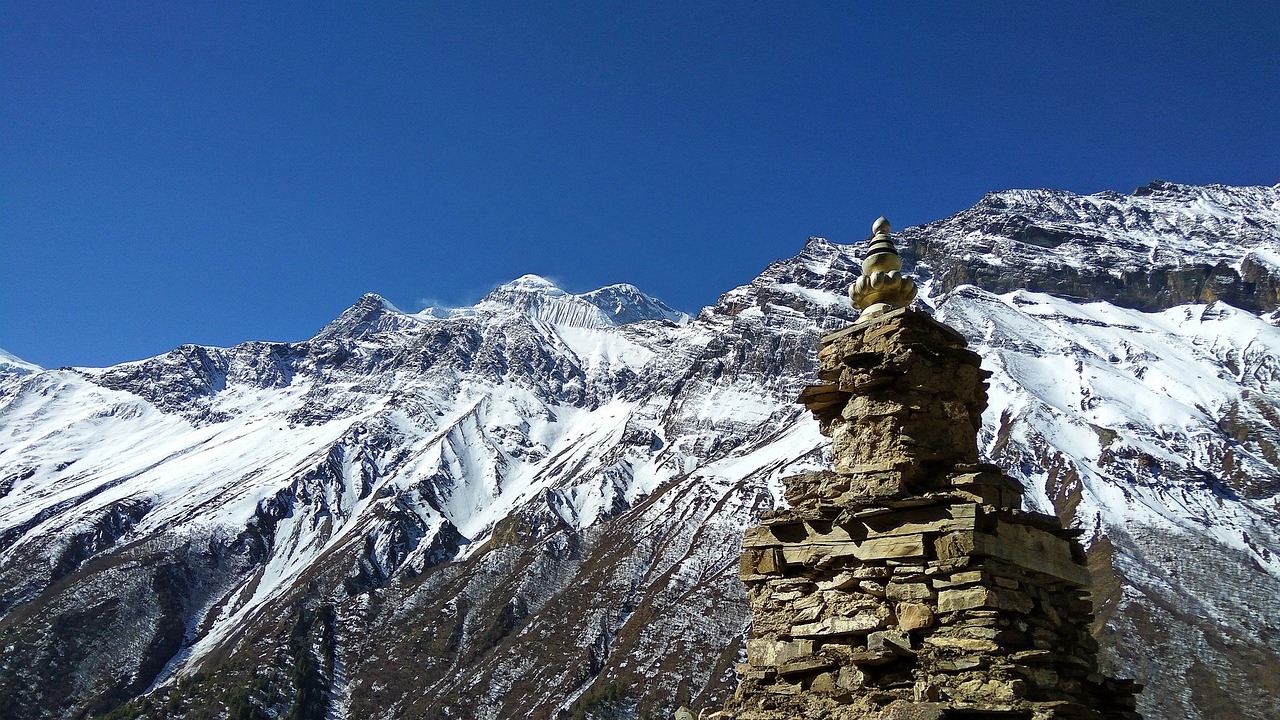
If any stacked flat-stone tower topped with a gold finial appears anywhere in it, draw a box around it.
[704,218,1139,720]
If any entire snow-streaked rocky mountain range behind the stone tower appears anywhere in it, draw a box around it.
[0,183,1280,719]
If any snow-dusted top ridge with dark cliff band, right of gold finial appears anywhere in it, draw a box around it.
[901,181,1280,313]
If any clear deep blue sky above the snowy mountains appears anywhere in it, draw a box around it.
[0,0,1280,366]
